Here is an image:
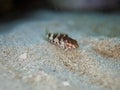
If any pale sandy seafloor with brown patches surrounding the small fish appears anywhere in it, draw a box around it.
[0,10,120,90]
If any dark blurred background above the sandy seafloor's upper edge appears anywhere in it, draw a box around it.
[0,0,120,21]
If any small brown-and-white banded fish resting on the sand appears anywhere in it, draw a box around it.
[47,33,79,50]
